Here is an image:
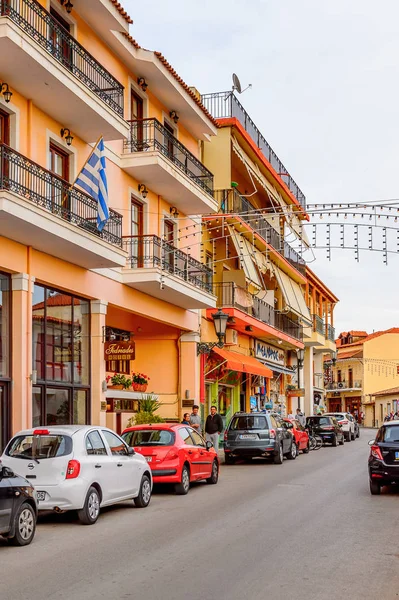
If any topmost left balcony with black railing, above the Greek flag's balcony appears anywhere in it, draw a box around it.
[0,0,128,142]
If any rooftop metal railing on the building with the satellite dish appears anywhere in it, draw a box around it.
[201,92,306,209]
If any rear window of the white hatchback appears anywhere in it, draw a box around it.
[6,434,72,459]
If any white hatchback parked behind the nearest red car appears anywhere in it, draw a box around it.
[1,425,152,525]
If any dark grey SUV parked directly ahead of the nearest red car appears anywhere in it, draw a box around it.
[224,412,297,465]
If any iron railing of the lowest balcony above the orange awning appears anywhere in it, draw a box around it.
[213,282,303,340]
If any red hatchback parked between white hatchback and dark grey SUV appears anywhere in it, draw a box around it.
[122,423,219,494]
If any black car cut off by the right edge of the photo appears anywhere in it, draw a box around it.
[369,421,399,495]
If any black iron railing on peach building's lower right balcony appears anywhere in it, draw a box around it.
[123,235,213,294]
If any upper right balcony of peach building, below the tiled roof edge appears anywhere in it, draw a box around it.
[122,119,217,215]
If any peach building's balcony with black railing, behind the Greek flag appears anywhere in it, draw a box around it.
[0,144,126,269]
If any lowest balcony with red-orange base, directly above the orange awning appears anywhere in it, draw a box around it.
[214,282,303,341]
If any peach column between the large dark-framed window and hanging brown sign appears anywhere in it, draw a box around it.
[90,300,108,426]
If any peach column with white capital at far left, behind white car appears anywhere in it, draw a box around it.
[11,273,35,434]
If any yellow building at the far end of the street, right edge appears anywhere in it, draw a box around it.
[325,327,399,427]
